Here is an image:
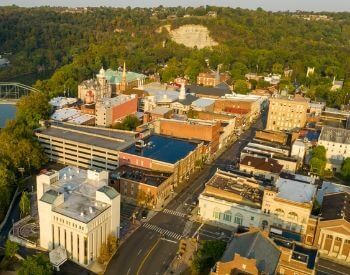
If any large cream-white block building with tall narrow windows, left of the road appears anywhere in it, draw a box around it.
[37,166,120,265]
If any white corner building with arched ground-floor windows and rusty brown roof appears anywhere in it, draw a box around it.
[199,170,270,229]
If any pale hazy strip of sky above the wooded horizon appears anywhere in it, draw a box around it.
[0,0,350,11]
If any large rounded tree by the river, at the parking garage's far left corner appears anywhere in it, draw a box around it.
[17,92,51,129]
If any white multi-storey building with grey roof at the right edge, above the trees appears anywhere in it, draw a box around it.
[318,126,350,171]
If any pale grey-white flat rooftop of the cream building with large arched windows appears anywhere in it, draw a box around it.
[276,178,317,203]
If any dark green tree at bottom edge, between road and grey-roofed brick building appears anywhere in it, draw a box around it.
[191,241,226,275]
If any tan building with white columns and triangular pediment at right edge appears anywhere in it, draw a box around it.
[314,192,350,265]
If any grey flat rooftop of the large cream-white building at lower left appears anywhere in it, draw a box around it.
[41,166,110,223]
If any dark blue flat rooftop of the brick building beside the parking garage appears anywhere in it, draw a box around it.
[123,135,198,164]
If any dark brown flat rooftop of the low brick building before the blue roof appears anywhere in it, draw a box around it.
[111,165,171,187]
